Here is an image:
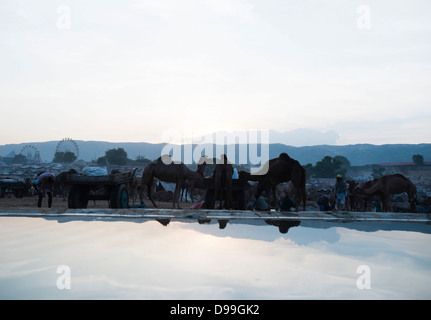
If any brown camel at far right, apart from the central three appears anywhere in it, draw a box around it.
[361,173,416,212]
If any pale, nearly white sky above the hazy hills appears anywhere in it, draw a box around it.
[0,0,431,145]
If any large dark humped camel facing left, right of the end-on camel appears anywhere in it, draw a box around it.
[240,153,307,211]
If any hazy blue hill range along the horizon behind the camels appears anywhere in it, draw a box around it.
[0,140,431,166]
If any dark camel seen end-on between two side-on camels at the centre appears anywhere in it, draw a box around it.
[211,154,233,209]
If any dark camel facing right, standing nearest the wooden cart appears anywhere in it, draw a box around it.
[141,155,206,208]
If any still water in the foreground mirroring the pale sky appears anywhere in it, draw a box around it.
[0,217,431,299]
